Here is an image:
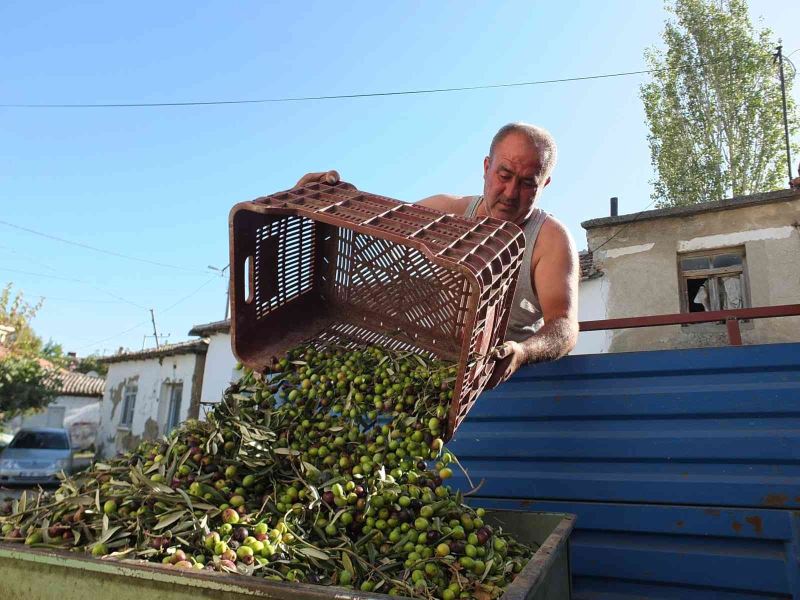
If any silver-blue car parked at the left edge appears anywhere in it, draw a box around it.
[0,427,72,485]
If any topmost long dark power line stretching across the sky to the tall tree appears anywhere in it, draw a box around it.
[0,59,727,108]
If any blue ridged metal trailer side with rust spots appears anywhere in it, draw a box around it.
[450,344,800,600]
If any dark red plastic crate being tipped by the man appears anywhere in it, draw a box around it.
[230,183,525,439]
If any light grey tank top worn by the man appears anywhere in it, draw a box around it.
[464,196,547,342]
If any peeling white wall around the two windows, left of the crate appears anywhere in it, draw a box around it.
[98,354,205,457]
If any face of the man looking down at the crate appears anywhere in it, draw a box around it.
[483,132,550,225]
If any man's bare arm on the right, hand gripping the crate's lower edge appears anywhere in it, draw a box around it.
[487,218,579,387]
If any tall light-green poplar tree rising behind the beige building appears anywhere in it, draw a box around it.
[640,0,797,207]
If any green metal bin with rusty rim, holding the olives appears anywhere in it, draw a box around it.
[0,510,574,600]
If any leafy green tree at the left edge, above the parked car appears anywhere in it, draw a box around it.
[0,284,61,423]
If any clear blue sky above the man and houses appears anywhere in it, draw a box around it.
[0,0,800,355]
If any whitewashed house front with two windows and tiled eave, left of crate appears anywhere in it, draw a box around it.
[97,338,208,457]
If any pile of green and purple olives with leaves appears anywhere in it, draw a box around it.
[0,345,532,600]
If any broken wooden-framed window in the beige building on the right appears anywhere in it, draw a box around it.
[678,248,749,312]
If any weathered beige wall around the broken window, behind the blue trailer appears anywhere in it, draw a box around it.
[587,196,800,352]
